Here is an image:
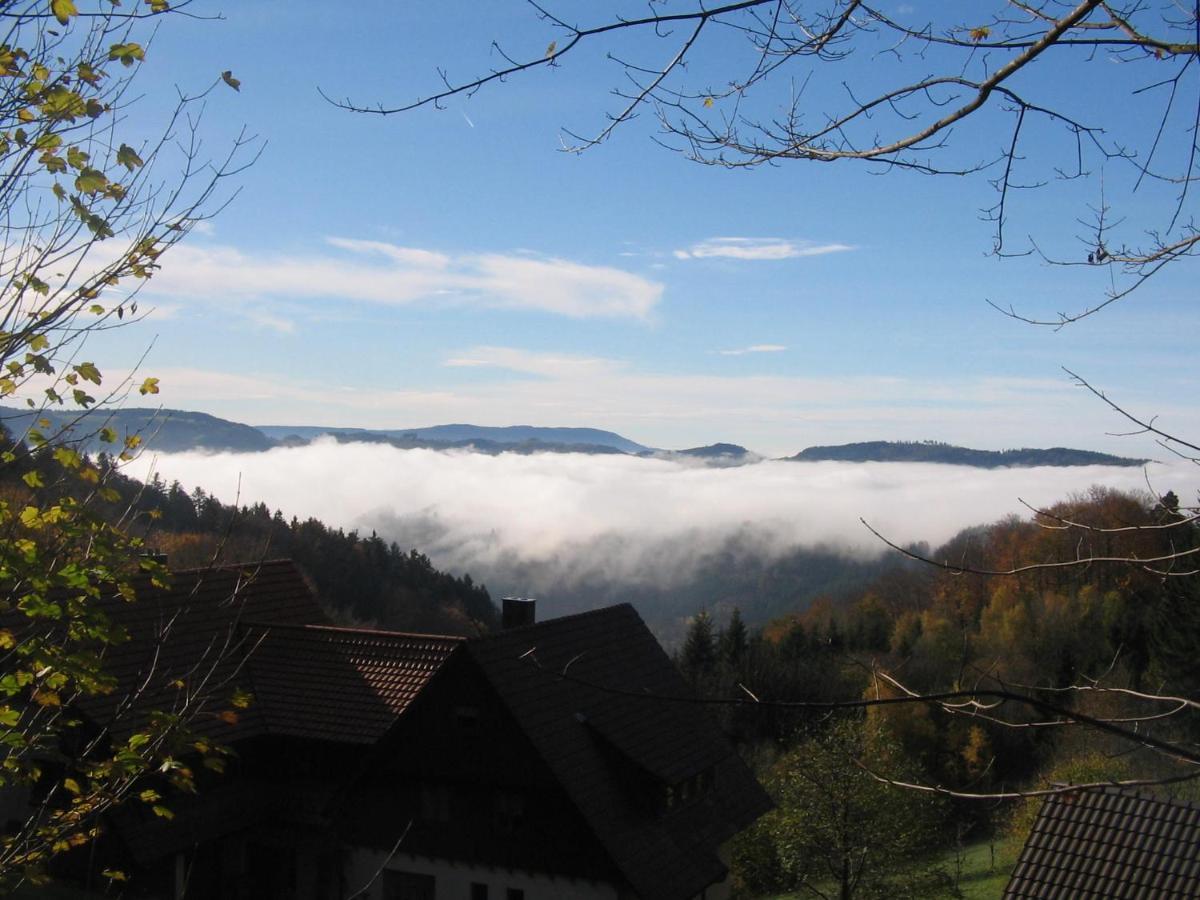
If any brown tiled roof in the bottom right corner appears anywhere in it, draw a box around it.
[1004,788,1200,900]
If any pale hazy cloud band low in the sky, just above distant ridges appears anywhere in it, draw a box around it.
[121,347,1171,458]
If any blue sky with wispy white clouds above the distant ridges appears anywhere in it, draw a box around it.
[90,0,1200,456]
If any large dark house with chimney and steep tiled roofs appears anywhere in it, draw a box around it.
[65,560,769,900]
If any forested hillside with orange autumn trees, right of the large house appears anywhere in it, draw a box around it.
[677,488,1200,896]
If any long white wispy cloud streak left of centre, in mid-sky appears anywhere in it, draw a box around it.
[148,238,664,319]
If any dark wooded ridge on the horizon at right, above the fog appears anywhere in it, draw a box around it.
[786,440,1150,469]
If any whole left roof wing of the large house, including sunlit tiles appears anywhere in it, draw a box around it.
[84,560,462,744]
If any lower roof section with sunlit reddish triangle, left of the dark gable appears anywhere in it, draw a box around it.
[247,624,462,744]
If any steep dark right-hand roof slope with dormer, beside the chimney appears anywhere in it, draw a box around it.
[467,604,770,900]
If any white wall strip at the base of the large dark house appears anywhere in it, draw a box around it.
[346,848,618,900]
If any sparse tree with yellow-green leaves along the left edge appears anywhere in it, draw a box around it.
[0,0,252,890]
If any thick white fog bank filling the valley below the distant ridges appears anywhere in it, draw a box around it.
[130,439,1200,595]
